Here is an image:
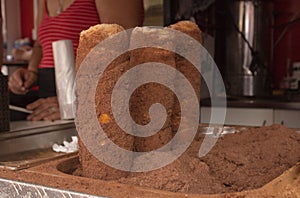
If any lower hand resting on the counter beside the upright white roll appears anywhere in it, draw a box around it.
[26,97,60,121]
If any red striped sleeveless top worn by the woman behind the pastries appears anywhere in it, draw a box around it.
[38,0,100,68]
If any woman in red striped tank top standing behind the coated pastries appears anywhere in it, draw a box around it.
[9,0,143,121]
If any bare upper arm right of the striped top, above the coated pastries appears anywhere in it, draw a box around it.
[95,0,142,29]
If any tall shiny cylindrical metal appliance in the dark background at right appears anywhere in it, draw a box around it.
[220,0,273,96]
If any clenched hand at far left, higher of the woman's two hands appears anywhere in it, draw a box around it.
[8,68,37,95]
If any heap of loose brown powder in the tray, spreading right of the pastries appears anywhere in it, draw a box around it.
[74,125,300,194]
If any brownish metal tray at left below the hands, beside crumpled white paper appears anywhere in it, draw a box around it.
[0,121,77,170]
